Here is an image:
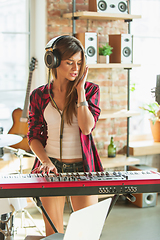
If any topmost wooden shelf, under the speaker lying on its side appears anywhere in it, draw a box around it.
[63,11,141,21]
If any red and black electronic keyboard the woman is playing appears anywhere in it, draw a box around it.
[0,171,160,198]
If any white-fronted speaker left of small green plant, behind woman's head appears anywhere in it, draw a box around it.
[75,32,98,64]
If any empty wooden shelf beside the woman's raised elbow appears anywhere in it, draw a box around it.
[99,109,139,120]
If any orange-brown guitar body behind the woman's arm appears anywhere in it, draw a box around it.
[8,108,31,152]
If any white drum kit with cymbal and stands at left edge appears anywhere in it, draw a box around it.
[0,134,42,240]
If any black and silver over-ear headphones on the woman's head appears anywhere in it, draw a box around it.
[44,35,69,69]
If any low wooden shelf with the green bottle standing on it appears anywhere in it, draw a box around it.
[101,154,140,168]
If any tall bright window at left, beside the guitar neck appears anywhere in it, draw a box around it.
[0,0,30,132]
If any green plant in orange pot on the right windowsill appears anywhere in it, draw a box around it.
[140,102,160,142]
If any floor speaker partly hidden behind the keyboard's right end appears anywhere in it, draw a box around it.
[128,164,157,208]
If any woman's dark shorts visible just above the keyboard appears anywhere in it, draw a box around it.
[49,157,84,173]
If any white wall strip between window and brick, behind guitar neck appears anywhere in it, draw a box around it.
[30,0,47,90]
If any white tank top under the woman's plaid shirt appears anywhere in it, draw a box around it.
[44,102,82,159]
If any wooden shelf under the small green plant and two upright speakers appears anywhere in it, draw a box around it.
[87,63,141,69]
